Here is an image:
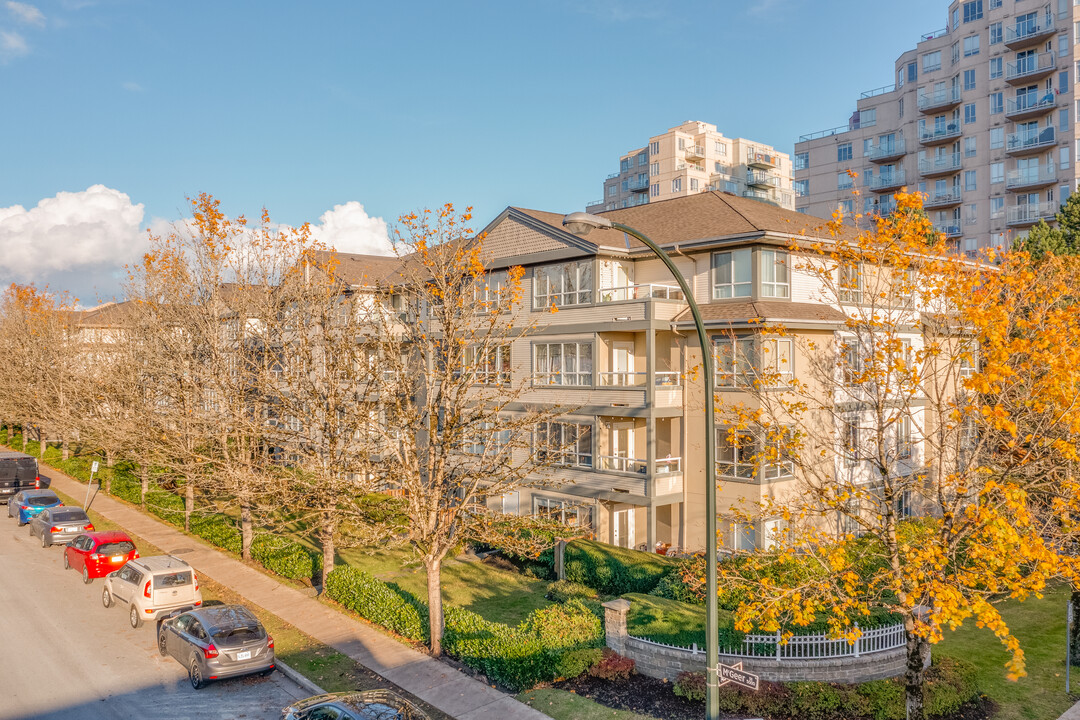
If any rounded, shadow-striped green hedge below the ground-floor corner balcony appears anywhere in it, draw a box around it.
[563,540,676,595]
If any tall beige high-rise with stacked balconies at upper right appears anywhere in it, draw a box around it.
[795,0,1080,254]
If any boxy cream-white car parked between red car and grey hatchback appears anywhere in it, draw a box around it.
[102,555,202,627]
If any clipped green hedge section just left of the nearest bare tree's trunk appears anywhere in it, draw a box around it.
[324,567,428,642]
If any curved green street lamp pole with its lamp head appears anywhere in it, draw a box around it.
[563,213,720,720]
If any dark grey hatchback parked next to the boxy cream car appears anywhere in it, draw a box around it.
[158,604,275,690]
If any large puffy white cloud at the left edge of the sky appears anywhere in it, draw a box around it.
[0,185,147,283]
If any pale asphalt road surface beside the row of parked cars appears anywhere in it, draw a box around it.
[0,505,308,720]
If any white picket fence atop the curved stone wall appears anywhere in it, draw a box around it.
[630,623,907,661]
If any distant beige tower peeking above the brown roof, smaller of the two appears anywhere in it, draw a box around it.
[588,121,795,213]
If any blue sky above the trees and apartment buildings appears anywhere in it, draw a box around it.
[0,0,946,297]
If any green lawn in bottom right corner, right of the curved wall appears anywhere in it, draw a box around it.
[933,587,1080,720]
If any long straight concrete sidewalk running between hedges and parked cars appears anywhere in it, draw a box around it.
[42,467,548,720]
